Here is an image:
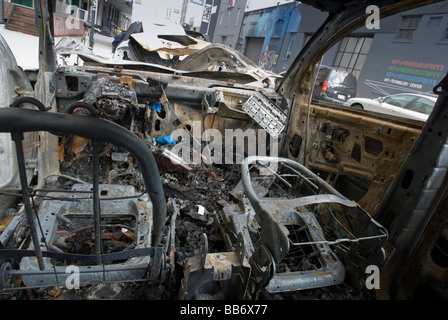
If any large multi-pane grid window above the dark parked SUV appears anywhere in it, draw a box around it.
[334,37,373,77]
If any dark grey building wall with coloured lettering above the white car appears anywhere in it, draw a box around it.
[354,1,448,98]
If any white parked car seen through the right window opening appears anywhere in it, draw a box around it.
[344,93,437,121]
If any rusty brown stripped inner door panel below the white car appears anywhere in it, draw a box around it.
[285,104,423,213]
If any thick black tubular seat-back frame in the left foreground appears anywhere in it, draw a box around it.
[0,97,167,286]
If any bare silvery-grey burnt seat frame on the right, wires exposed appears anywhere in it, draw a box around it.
[238,156,388,292]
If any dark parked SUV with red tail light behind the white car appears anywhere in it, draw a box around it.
[313,66,358,104]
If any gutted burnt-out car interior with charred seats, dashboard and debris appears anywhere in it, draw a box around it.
[0,0,448,300]
